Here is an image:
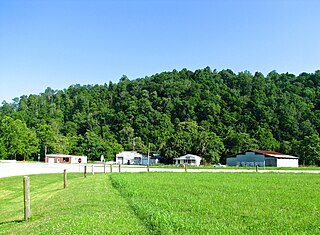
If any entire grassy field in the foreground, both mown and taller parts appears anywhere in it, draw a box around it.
[0,172,320,234]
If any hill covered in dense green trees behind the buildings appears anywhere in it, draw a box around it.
[0,67,320,164]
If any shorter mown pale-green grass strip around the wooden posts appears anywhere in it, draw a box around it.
[0,173,147,234]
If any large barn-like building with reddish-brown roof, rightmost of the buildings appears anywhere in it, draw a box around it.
[227,150,299,167]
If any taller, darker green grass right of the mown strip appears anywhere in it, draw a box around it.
[111,173,320,234]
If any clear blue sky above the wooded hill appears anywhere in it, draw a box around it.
[0,0,320,104]
